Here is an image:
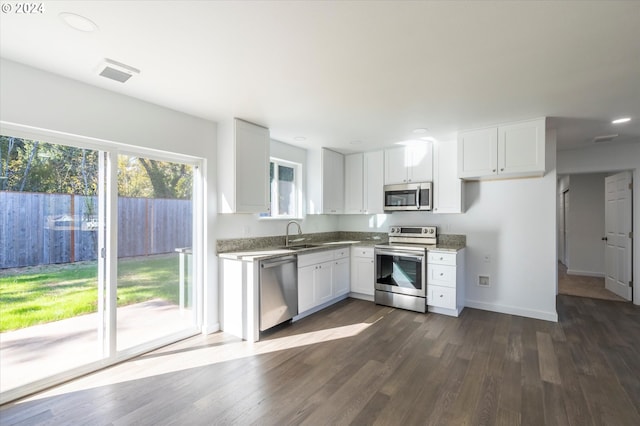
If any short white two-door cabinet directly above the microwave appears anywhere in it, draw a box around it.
[384,142,433,185]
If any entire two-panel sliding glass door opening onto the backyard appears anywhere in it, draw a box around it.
[0,132,201,403]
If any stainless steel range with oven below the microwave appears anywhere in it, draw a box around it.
[374,226,437,312]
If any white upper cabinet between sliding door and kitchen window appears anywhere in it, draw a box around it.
[218,118,270,213]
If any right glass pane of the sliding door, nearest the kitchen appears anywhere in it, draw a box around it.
[116,155,196,351]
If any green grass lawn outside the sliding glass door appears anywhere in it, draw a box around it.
[0,254,179,332]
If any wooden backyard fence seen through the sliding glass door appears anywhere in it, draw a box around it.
[0,191,192,269]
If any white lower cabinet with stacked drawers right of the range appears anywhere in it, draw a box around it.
[427,249,464,317]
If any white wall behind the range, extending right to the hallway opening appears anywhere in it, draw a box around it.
[339,133,557,321]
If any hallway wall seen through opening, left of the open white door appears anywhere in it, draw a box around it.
[567,173,607,277]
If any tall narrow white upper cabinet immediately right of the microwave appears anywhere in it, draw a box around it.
[433,142,463,213]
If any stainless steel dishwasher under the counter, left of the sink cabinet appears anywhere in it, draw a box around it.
[260,256,298,331]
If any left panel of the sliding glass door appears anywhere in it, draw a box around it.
[0,135,104,400]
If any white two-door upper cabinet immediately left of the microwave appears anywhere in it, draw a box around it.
[344,151,384,214]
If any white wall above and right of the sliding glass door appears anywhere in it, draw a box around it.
[0,59,218,330]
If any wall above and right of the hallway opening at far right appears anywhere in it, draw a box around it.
[557,141,640,305]
